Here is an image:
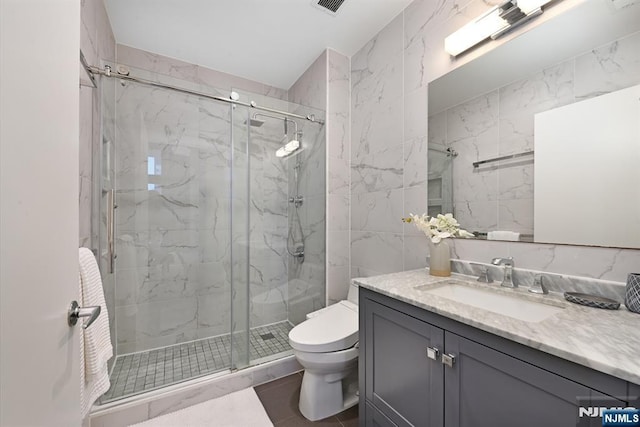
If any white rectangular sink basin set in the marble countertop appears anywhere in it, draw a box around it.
[419,280,564,322]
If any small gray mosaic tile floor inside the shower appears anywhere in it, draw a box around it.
[100,321,291,404]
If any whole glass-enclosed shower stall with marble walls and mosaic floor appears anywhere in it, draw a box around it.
[95,63,326,403]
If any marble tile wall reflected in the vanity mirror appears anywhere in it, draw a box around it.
[429,32,640,234]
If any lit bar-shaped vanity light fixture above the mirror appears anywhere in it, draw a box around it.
[444,0,551,56]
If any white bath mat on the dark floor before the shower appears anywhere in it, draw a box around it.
[131,388,273,427]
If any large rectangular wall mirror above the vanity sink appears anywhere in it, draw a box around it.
[428,0,640,248]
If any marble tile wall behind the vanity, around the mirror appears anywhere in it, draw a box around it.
[350,0,640,288]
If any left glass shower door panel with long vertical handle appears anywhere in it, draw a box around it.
[101,70,248,403]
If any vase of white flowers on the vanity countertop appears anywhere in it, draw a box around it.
[403,213,474,277]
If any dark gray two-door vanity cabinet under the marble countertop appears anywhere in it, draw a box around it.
[359,288,627,427]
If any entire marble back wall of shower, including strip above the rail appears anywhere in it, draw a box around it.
[111,45,296,353]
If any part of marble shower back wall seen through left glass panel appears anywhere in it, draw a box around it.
[116,84,231,353]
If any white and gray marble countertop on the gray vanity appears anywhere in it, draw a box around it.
[353,269,640,384]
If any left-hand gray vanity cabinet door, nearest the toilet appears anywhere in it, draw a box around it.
[361,300,444,427]
